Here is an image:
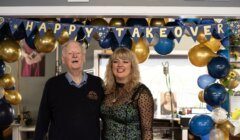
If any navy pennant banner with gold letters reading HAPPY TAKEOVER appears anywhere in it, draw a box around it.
[0,17,240,43]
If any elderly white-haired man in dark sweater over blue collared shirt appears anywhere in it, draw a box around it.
[34,41,104,140]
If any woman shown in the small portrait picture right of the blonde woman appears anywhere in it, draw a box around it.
[161,92,177,115]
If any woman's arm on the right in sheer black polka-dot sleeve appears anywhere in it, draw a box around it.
[138,89,154,140]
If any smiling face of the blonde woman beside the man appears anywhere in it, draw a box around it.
[112,58,131,83]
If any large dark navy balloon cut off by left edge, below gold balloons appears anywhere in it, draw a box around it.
[0,98,14,126]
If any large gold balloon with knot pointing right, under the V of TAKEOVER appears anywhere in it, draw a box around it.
[188,44,217,67]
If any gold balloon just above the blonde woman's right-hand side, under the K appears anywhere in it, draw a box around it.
[131,38,149,63]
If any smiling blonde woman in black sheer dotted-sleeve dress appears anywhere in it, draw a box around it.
[101,47,154,140]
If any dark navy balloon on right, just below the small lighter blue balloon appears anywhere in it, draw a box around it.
[204,83,228,107]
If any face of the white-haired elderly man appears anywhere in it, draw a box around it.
[62,43,85,71]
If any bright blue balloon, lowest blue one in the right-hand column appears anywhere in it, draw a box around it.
[189,114,214,136]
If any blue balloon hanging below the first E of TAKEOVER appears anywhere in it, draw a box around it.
[154,38,175,55]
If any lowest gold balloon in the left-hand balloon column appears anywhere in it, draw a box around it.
[4,90,22,105]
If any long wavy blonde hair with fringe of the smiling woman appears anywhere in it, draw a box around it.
[105,47,140,94]
